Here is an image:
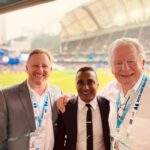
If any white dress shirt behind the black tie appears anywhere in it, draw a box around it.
[76,98,104,150]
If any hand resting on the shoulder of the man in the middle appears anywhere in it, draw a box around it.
[56,94,75,113]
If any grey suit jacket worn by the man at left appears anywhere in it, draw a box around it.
[0,81,61,150]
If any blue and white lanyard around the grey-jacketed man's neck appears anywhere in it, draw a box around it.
[33,93,49,127]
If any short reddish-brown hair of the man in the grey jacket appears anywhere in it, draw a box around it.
[27,48,52,62]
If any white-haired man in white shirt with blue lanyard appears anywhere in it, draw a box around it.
[101,38,150,150]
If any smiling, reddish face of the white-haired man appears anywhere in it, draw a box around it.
[111,45,144,90]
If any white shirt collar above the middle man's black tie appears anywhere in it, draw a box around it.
[78,96,97,110]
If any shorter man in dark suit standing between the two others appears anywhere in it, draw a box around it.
[54,67,110,150]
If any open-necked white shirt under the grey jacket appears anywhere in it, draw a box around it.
[27,82,54,150]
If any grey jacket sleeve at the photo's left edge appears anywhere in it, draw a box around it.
[0,91,7,150]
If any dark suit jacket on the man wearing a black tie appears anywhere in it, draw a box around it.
[54,96,110,150]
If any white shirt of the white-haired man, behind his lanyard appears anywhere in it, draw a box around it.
[100,75,150,150]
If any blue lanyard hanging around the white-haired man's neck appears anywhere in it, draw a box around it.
[116,75,147,128]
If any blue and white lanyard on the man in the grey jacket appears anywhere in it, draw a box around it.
[33,93,48,127]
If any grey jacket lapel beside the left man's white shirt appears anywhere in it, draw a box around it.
[19,81,36,131]
